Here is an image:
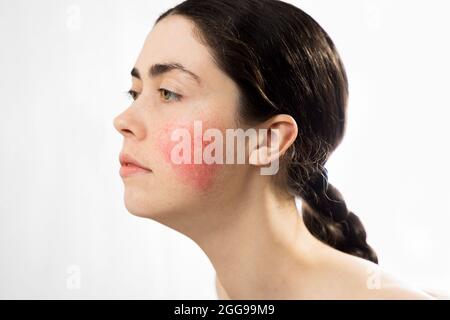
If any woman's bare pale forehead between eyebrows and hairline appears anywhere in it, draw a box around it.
[136,16,217,79]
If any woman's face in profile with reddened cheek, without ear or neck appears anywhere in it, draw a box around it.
[114,16,248,223]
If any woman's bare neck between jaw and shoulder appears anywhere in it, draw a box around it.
[178,180,324,299]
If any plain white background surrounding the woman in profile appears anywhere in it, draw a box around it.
[0,0,450,299]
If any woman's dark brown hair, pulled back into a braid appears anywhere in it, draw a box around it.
[156,0,378,263]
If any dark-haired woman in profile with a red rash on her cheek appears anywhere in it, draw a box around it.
[114,0,432,299]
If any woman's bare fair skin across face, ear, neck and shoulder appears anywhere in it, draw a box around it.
[114,16,431,299]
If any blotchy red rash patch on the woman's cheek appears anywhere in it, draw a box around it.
[158,121,220,191]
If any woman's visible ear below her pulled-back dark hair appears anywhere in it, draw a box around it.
[249,114,298,166]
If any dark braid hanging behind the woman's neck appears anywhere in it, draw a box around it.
[300,168,378,263]
